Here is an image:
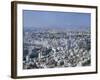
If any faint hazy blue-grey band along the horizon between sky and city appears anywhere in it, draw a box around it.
[24,26,91,32]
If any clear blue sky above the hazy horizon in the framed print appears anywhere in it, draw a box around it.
[23,10,91,29]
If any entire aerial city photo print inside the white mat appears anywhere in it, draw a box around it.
[23,10,91,69]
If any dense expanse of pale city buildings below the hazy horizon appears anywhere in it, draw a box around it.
[23,30,91,69]
